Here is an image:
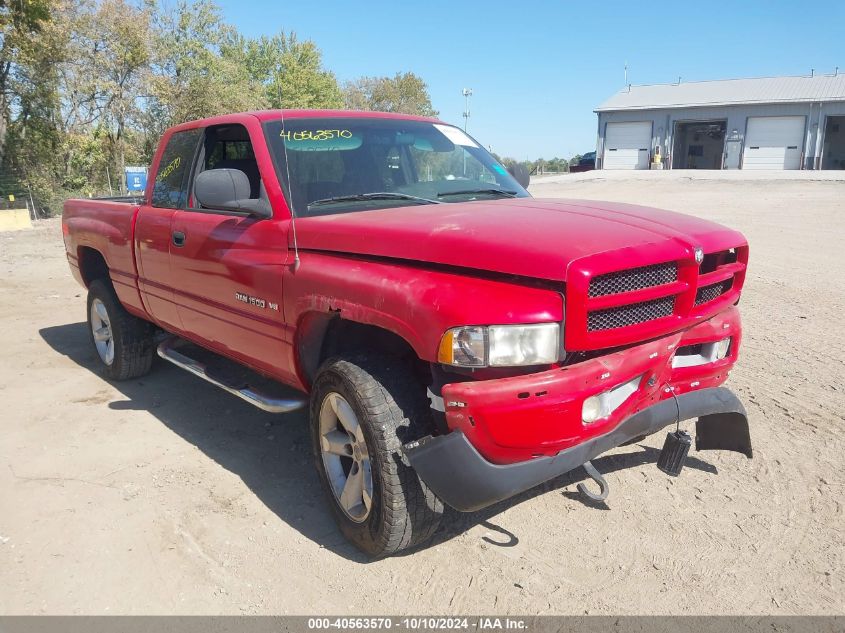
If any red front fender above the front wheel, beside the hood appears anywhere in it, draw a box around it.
[284,251,564,362]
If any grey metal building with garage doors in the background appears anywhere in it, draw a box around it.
[595,71,845,169]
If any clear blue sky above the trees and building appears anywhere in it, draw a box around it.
[218,0,845,159]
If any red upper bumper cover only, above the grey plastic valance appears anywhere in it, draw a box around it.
[432,307,742,464]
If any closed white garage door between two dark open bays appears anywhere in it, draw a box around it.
[742,116,804,169]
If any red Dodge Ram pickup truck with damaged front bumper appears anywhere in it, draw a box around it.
[62,110,751,556]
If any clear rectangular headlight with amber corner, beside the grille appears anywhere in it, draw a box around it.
[437,323,560,367]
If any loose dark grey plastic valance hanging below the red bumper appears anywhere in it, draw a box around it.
[404,387,751,512]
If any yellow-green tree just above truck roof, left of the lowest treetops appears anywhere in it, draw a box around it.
[241,33,343,109]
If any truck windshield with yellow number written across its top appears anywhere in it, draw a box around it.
[264,117,528,217]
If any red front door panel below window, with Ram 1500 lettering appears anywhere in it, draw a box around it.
[170,211,294,382]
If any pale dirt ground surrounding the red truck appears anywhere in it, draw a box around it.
[0,175,845,614]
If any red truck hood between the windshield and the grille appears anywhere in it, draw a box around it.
[296,198,745,281]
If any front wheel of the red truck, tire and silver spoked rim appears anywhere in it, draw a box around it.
[311,356,443,557]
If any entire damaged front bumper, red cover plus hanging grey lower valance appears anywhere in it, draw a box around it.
[405,307,751,511]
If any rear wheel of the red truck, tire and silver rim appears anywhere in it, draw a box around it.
[88,279,155,380]
